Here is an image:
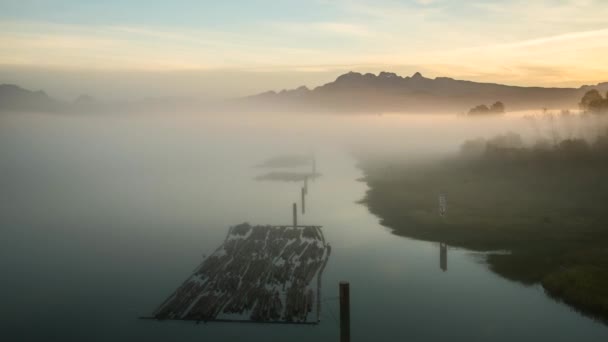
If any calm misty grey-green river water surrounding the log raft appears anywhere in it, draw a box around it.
[0,114,608,341]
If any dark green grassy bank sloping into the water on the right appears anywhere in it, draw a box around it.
[360,140,608,320]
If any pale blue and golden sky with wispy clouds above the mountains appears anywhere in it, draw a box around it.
[0,0,608,99]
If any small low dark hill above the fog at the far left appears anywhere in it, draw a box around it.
[0,84,66,112]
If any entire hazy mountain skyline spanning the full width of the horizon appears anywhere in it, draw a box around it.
[0,71,608,113]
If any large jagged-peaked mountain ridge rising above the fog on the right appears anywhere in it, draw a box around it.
[239,71,608,113]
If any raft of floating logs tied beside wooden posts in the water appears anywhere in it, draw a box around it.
[148,223,331,324]
